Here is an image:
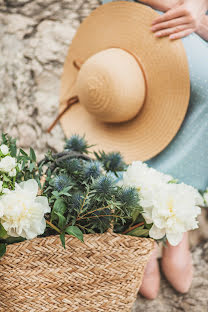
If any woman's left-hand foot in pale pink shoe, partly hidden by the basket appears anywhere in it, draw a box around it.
[139,243,160,299]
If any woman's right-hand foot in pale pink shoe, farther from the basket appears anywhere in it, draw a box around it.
[161,233,193,293]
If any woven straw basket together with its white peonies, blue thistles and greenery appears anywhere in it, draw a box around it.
[0,134,203,312]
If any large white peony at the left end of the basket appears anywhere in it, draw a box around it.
[0,179,50,239]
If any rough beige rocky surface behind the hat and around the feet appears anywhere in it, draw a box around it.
[0,0,208,312]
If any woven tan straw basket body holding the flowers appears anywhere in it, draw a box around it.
[0,233,153,312]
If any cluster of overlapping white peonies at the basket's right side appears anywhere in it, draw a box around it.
[120,161,203,246]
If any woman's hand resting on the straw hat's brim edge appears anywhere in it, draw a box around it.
[152,0,208,39]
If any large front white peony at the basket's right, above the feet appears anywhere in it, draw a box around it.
[148,183,201,246]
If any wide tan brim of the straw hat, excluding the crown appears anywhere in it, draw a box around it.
[60,1,190,163]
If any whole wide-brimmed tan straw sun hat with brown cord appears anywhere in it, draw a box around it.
[50,1,190,162]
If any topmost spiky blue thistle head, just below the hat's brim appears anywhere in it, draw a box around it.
[64,134,90,154]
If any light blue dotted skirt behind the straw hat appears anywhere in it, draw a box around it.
[103,0,208,190]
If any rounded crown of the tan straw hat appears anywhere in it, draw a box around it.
[77,48,146,123]
